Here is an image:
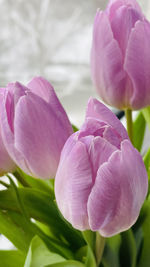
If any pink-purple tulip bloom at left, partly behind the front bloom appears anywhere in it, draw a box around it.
[1,77,73,178]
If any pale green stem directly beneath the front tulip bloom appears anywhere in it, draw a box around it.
[95,232,105,267]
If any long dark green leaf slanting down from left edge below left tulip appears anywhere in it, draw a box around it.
[0,188,85,251]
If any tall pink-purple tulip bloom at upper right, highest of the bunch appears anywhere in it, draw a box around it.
[91,0,150,110]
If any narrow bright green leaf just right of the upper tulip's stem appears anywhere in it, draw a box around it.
[133,112,146,151]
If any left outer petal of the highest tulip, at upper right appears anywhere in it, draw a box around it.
[91,12,132,109]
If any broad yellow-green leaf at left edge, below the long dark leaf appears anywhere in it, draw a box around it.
[0,210,34,251]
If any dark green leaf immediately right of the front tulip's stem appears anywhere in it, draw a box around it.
[102,234,121,267]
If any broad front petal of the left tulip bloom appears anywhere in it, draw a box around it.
[14,92,69,178]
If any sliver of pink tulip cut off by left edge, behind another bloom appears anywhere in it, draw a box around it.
[0,89,16,175]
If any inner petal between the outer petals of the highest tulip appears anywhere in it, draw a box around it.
[111,6,143,57]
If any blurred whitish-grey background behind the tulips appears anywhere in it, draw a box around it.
[0,0,150,249]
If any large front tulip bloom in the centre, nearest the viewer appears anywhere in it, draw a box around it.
[55,99,148,237]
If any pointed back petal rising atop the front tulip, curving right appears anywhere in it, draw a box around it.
[86,98,129,140]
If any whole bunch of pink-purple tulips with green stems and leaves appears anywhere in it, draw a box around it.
[0,0,150,267]
